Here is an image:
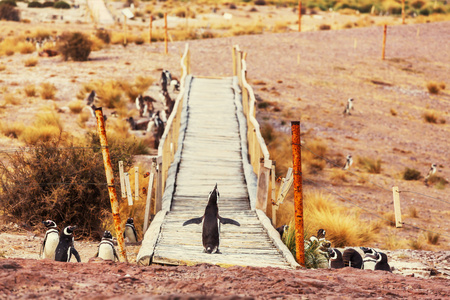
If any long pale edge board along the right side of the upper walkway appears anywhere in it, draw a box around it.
[233,76,258,210]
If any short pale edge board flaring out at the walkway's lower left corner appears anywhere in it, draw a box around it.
[136,210,168,266]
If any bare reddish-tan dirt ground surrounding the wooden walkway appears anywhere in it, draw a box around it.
[0,1,450,299]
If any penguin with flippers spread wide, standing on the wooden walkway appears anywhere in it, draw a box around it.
[183,183,241,254]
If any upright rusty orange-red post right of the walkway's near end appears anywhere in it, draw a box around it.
[291,121,305,266]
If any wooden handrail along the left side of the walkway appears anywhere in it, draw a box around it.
[155,44,190,213]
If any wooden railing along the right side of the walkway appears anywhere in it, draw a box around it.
[232,46,275,215]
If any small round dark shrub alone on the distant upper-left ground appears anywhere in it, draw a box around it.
[59,32,92,61]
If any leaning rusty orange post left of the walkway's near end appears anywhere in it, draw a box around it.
[95,107,128,262]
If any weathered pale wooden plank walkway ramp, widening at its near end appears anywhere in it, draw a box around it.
[138,77,293,268]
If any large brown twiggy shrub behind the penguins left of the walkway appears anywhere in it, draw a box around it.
[0,134,138,238]
